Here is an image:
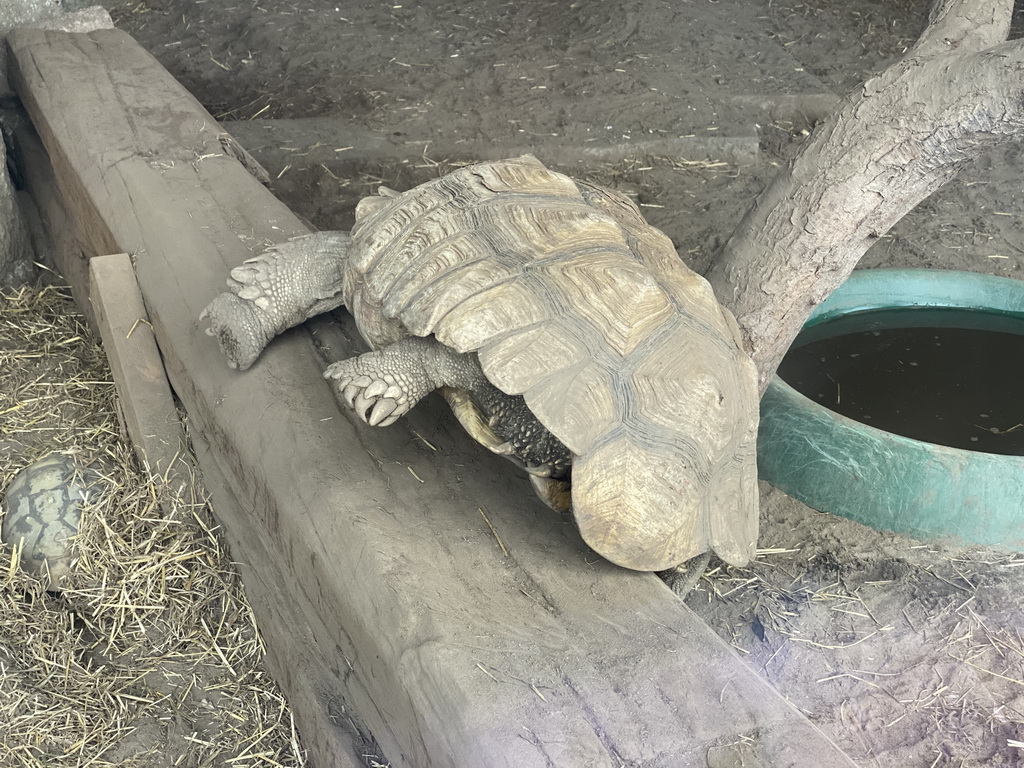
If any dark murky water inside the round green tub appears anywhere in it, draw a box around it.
[778,308,1024,456]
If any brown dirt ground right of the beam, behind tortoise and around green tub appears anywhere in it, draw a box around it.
[6,0,1024,768]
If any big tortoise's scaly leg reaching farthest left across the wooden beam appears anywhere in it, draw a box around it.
[200,231,349,371]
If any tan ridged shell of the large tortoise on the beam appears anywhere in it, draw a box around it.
[342,156,758,570]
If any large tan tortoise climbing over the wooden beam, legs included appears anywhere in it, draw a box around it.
[202,156,758,570]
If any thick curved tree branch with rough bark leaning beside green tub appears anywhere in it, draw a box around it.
[707,0,1024,391]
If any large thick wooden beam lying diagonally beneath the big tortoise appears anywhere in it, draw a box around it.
[8,31,852,768]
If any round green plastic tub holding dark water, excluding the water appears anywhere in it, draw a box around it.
[758,269,1024,551]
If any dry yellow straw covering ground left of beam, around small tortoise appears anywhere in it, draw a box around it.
[0,287,305,768]
